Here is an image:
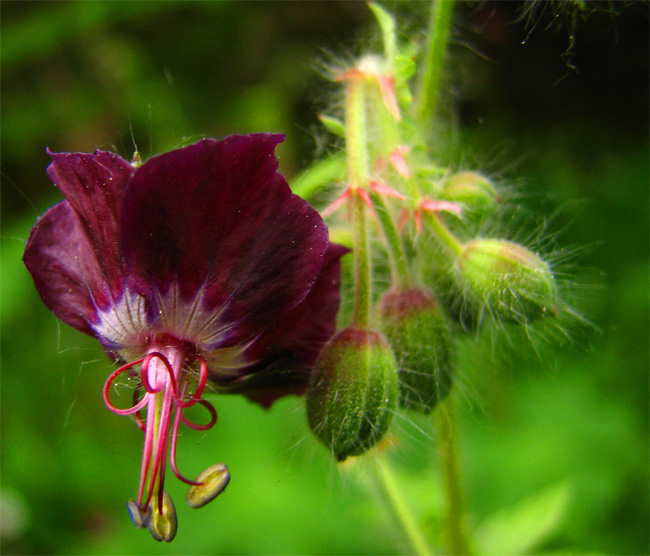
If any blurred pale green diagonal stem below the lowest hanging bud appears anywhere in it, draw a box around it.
[375,452,433,556]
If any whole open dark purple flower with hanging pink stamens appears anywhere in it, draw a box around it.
[24,134,346,541]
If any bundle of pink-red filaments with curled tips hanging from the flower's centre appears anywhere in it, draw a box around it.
[103,351,217,512]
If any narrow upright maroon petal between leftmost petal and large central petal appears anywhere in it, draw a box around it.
[47,151,133,297]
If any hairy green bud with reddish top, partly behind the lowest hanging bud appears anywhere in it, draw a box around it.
[378,288,451,414]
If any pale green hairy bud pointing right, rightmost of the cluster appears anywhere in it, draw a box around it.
[457,238,557,323]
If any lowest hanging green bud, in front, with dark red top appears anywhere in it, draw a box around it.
[307,328,398,461]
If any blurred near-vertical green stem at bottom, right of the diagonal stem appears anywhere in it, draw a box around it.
[437,396,470,556]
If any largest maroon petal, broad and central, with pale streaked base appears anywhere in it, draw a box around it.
[121,134,327,349]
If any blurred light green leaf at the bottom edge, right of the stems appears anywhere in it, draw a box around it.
[475,483,571,556]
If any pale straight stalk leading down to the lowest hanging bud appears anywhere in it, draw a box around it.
[345,77,370,328]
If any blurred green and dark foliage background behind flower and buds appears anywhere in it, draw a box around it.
[0,1,650,554]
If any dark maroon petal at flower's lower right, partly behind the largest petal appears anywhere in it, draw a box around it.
[210,243,349,407]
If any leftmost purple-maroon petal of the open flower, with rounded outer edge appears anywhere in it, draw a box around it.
[23,201,107,335]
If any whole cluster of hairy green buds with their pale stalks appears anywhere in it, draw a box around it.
[296,4,558,461]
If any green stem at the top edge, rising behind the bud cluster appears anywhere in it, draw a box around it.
[416,0,455,124]
